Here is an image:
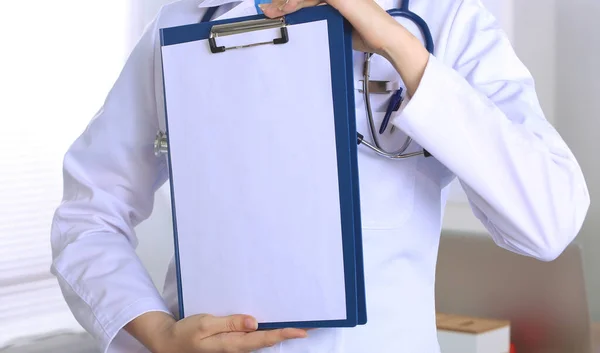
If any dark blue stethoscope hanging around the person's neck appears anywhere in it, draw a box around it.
[201,0,434,160]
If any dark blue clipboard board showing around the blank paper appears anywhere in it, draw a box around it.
[160,5,367,329]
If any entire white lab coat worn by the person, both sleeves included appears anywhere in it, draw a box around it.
[52,0,590,353]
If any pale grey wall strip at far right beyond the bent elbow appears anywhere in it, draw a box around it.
[556,0,600,321]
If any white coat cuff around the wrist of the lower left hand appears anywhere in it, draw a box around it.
[102,297,173,353]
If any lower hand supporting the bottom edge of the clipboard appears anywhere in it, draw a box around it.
[126,313,307,353]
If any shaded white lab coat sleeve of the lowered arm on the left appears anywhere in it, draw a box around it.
[51,13,169,352]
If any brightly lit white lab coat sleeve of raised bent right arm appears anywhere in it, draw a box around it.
[394,0,590,261]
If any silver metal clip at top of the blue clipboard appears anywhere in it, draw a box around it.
[208,17,289,54]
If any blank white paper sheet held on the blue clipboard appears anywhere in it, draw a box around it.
[163,21,346,322]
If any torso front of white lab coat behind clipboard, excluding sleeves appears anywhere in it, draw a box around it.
[157,0,457,353]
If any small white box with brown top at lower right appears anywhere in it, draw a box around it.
[437,313,510,353]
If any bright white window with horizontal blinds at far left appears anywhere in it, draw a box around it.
[0,0,129,348]
